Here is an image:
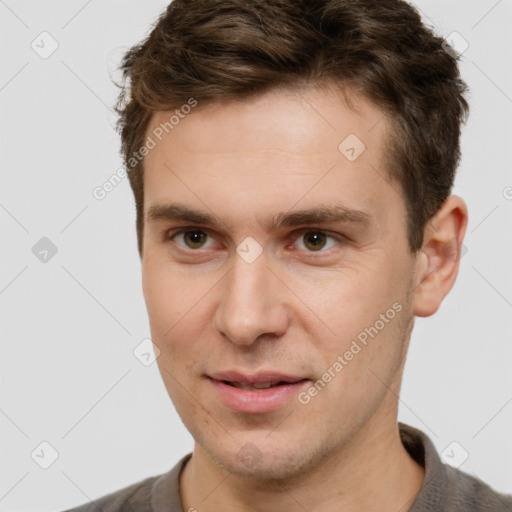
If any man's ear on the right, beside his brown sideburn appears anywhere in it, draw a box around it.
[413,195,468,316]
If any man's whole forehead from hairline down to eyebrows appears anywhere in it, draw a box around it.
[144,88,399,232]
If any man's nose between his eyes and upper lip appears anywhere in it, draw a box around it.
[215,252,289,345]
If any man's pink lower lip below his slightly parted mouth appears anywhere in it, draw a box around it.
[209,379,309,414]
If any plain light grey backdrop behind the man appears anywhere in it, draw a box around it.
[0,0,512,512]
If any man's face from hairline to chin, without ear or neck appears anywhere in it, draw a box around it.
[142,85,415,479]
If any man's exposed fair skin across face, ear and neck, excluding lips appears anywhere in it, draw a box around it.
[142,88,467,512]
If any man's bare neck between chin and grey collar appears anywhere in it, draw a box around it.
[180,416,425,512]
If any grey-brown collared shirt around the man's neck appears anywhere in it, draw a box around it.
[65,423,512,512]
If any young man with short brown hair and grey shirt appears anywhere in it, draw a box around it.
[64,0,512,512]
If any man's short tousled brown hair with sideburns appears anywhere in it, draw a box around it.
[116,0,469,256]
